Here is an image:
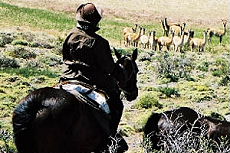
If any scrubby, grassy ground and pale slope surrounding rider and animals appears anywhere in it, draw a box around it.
[0,0,230,153]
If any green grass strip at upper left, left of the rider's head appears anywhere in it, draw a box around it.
[0,2,75,31]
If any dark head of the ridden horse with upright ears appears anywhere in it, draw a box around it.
[114,48,138,101]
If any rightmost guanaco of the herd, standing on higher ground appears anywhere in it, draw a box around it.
[208,20,227,44]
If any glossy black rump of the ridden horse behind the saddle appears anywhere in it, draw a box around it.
[13,87,106,153]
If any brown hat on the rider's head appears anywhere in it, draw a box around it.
[76,3,102,26]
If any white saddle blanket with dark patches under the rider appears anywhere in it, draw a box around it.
[62,84,110,114]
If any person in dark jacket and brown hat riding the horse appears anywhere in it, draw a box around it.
[62,3,127,152]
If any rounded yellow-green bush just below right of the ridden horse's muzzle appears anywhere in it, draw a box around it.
[134,92,162,109]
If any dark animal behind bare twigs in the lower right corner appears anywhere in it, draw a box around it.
[143,107,230,151]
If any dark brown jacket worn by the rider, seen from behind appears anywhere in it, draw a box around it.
[62,28,115,93]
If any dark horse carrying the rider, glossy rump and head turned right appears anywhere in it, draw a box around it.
[13,49,138,153]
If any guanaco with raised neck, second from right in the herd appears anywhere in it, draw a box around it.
[190,31,208,51]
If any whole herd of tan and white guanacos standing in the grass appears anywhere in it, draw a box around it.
[123,18,227,52]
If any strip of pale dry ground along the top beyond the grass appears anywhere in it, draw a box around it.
[3,0,230,26]
